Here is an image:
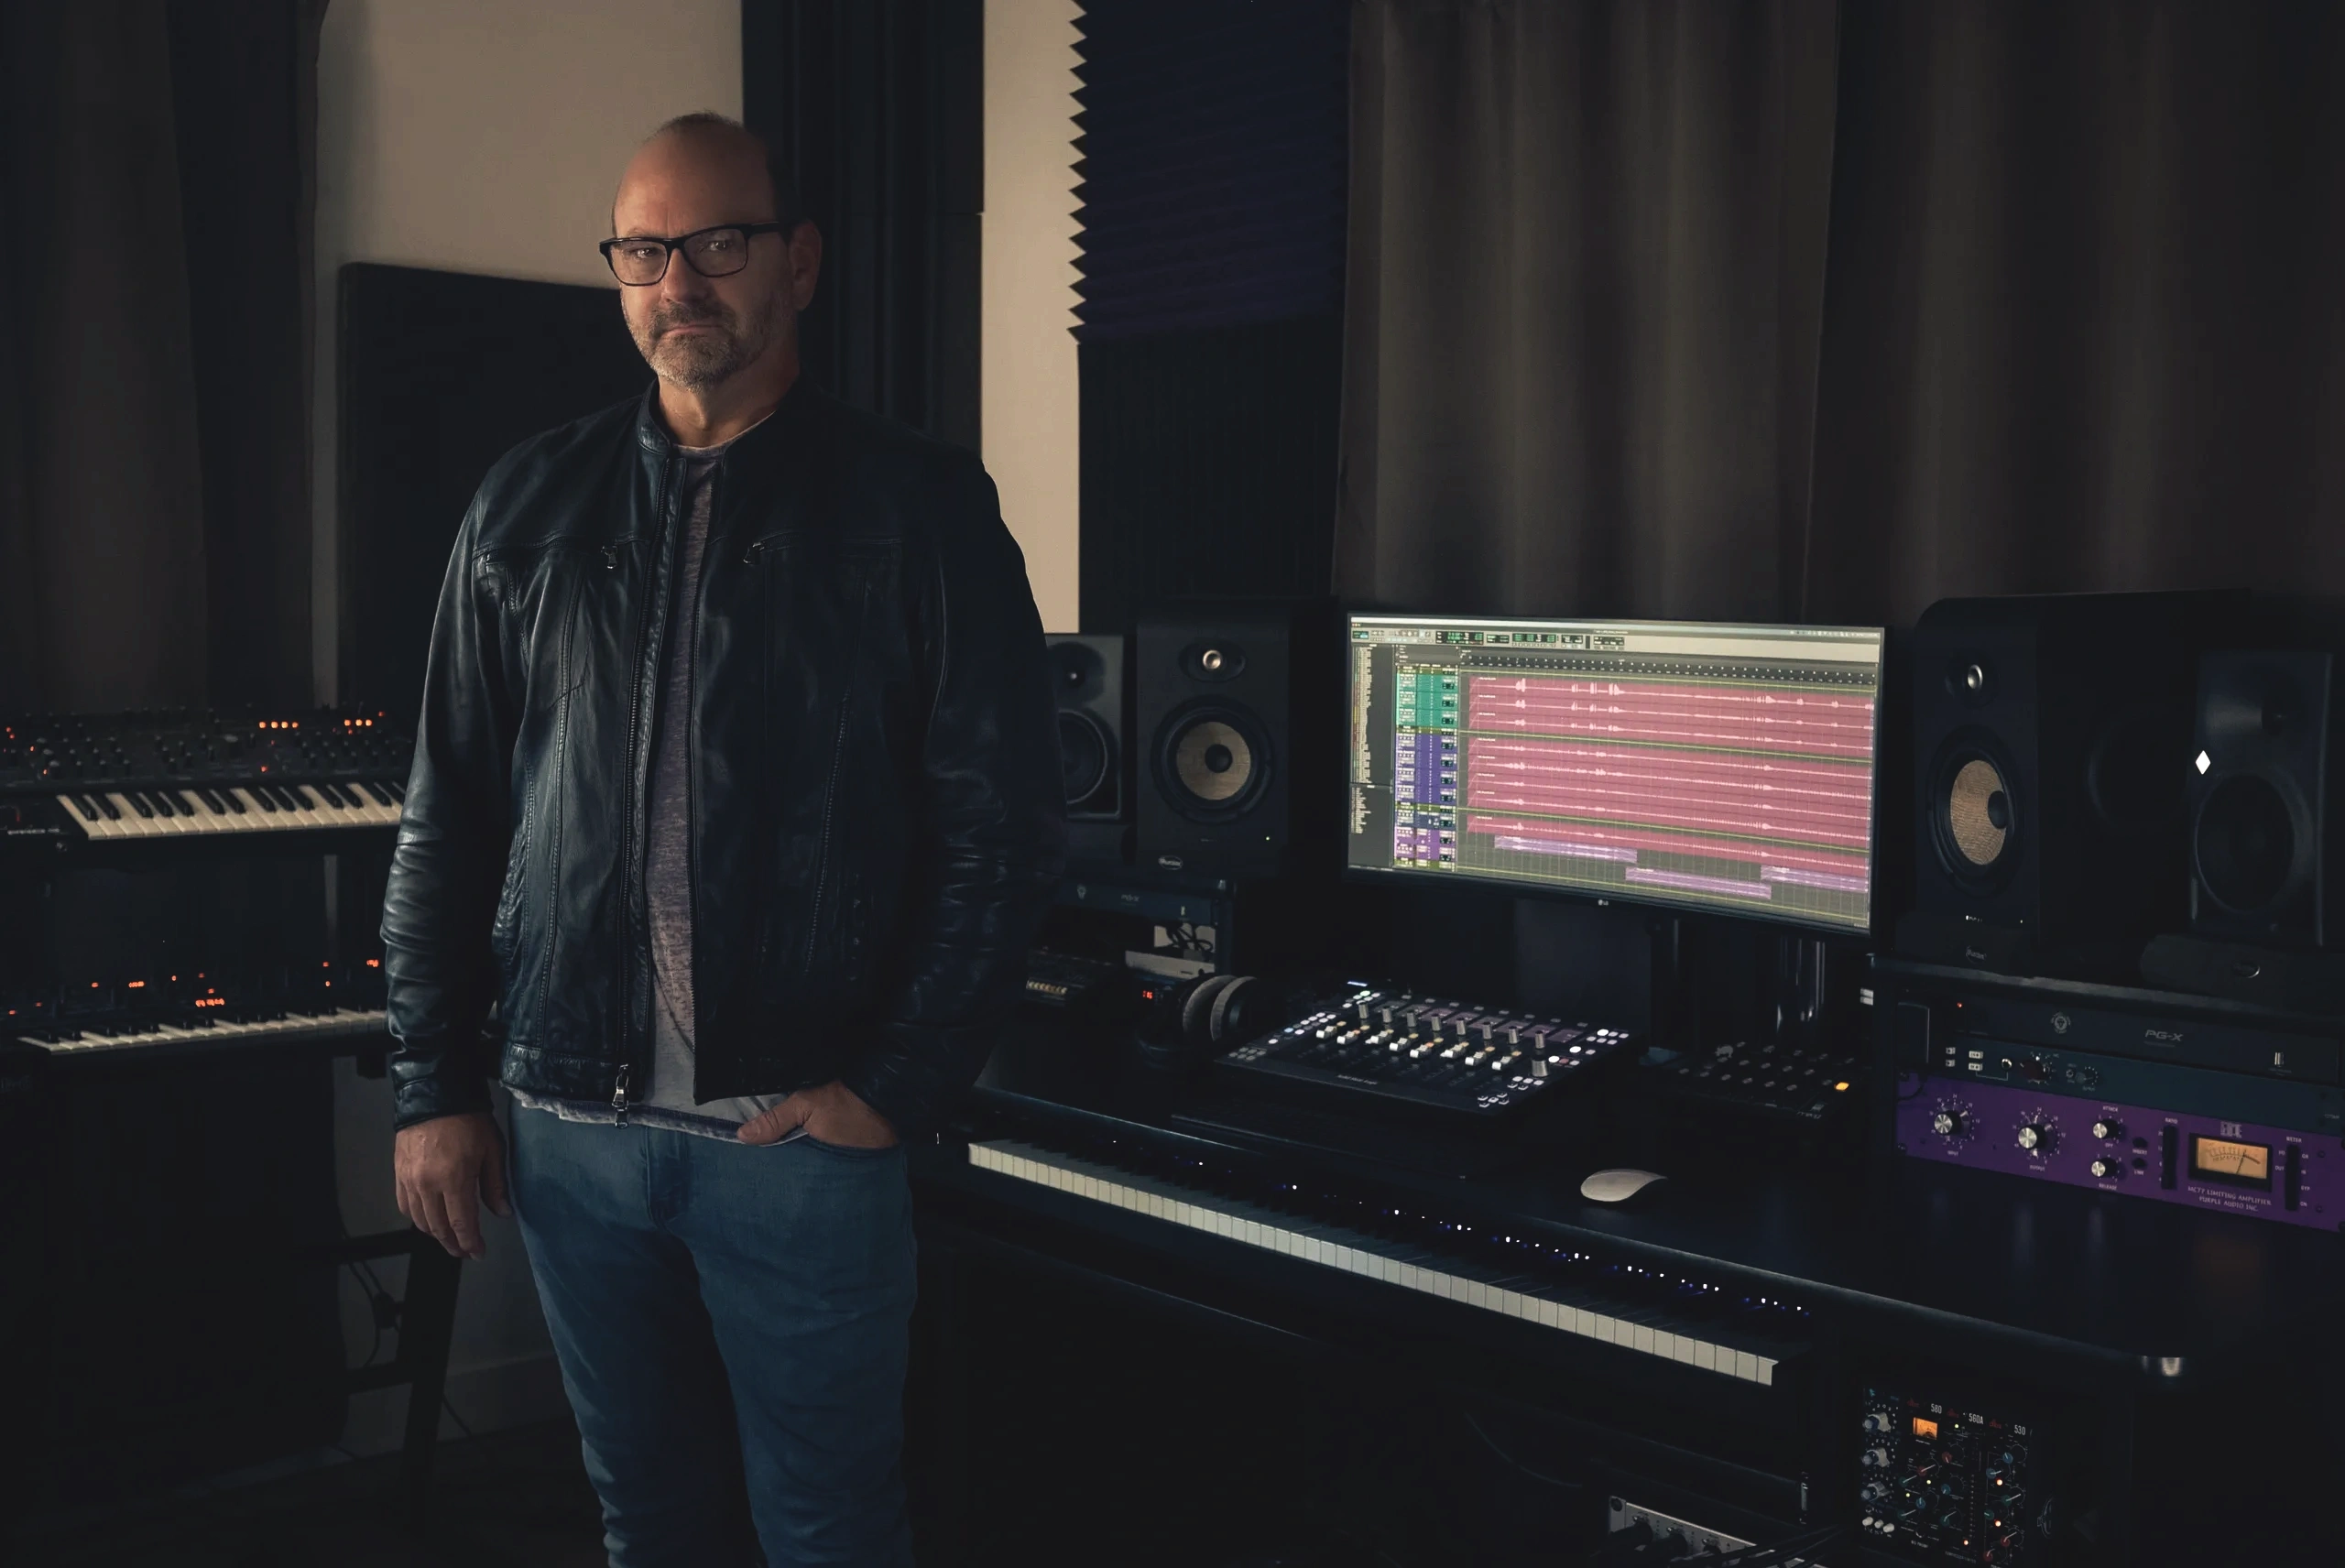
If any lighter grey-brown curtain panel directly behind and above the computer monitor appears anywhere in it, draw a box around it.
[1336,0,1834,616]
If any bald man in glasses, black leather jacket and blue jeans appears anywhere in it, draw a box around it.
[382,114,1063,1568]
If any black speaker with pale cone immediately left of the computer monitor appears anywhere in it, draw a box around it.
[1132,600,1344,875]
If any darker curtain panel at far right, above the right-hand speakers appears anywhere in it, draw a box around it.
[1784,0,2345,624]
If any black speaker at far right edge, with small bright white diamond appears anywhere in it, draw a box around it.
[2190,651,2345,947]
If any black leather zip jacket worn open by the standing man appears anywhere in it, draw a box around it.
[382,382,1063,1137]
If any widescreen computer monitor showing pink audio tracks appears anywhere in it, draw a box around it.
[1346,614,1883,932]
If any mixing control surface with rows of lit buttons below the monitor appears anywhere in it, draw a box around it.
[1217,986,1632,1116]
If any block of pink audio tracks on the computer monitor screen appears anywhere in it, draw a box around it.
[1463,678,1873,886]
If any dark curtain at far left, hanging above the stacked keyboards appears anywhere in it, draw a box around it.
[0,0,323,708]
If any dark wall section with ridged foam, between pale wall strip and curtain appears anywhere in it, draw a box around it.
[1076,0,1348,633]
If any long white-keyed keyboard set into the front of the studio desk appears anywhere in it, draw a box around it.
[968,1129,1808,1388]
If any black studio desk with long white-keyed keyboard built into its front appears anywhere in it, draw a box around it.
[912,1027,2345,1563]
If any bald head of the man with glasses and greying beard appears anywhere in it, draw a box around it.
[610,114,823,412]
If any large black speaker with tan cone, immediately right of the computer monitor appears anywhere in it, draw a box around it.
[1897,593,2244,970]
